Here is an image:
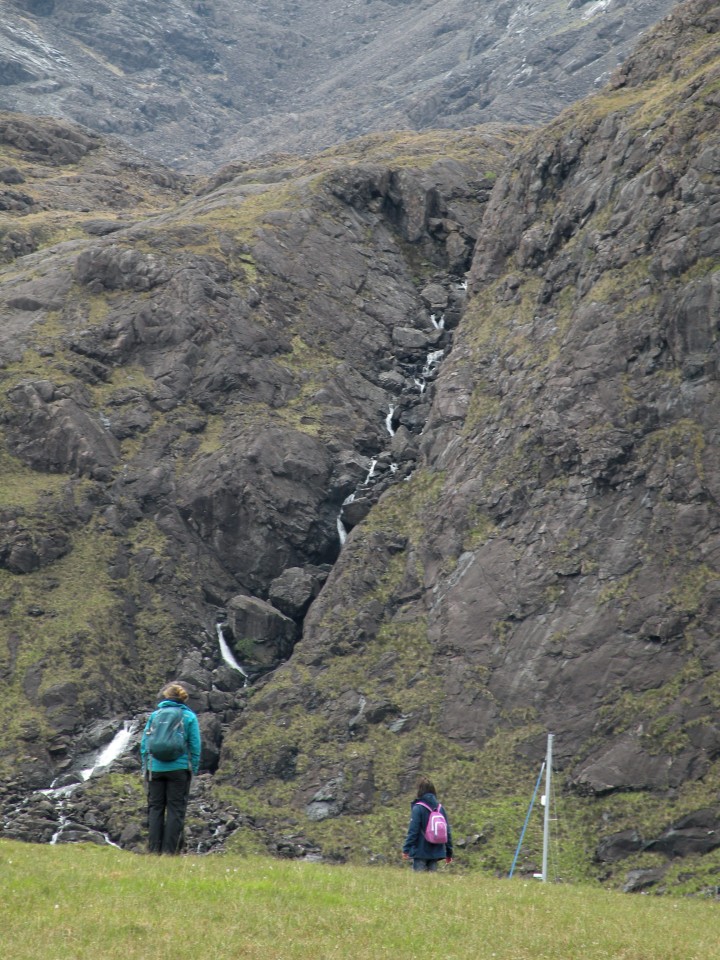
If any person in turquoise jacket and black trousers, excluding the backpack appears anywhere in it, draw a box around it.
[140,683,201,853]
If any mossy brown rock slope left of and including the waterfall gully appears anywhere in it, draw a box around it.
[0,115,521,836]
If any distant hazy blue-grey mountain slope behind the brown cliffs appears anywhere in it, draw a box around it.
[0,0,672,169]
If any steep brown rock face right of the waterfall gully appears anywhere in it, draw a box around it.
[221,3,720,884]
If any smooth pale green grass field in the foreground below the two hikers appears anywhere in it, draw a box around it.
[0,842,720,960]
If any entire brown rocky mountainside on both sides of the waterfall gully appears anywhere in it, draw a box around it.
[0,0,720,887]
